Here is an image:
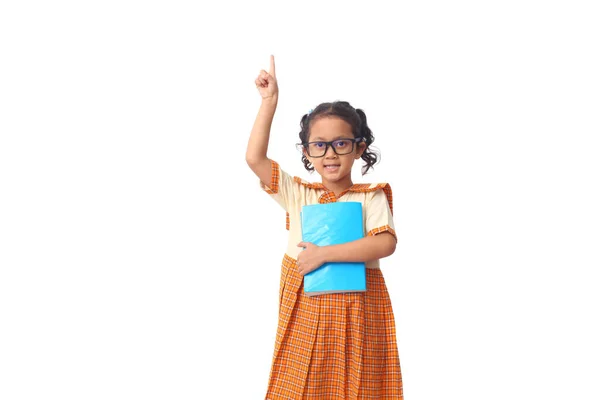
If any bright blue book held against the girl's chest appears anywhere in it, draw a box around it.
[300,201,367,296]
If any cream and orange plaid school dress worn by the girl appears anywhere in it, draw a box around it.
[260,161,404,400]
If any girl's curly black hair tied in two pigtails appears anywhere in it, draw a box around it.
[299,101,380,175]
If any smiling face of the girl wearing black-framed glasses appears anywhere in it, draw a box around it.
[304,117,366,183]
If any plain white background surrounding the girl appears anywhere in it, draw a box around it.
[0,0,600,400]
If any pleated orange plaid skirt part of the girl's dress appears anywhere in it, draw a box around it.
[266,254,403,400]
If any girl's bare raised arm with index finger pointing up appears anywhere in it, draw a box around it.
[246,56,279,184]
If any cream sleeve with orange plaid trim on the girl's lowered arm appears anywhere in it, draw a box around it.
[365,184,398,240]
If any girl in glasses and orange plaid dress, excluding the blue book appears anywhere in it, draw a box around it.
[246,56,403,400]
